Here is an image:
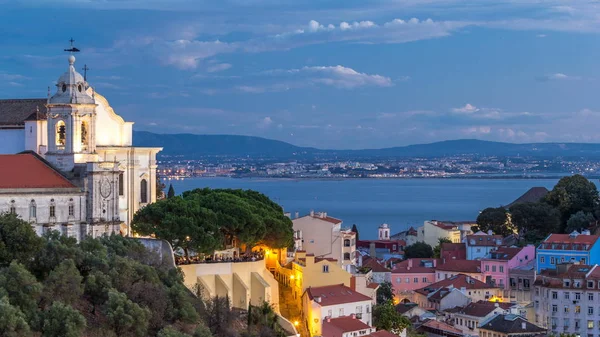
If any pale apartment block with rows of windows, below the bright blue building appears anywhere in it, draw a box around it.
[533,263,600,337]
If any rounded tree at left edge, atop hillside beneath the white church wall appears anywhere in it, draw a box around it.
[0,213,43,267]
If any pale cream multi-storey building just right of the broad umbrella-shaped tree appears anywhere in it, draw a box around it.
[292,211,356,272]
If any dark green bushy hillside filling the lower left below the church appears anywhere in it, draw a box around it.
[0,214,282,337]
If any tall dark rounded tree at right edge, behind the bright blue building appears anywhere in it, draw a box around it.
[544,174,599,229]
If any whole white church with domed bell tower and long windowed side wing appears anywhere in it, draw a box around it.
[0,55,162,238]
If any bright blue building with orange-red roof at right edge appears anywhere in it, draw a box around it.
[536,231,600,274]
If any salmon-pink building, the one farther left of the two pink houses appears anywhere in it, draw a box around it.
[392,258,439,301]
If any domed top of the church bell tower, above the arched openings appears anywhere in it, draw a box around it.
[49,55,95,104]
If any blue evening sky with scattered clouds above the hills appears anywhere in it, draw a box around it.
[0,0,600,148]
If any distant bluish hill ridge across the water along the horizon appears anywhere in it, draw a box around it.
[133,131,600,159]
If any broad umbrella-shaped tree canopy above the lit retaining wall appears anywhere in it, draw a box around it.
[132,188,293,254]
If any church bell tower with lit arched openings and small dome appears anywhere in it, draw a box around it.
[46,50,96,171]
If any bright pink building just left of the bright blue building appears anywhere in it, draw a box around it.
[481,245,535,290]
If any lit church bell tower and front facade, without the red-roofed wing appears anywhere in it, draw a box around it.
[0,55,161,235]
